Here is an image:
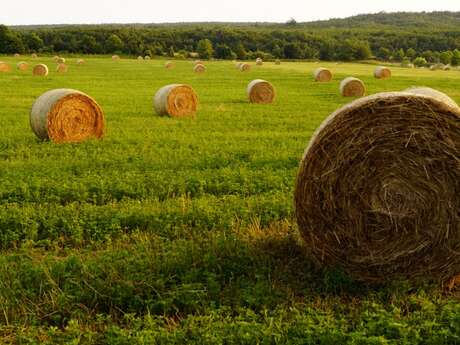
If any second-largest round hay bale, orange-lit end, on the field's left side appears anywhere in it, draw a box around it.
[30,89,104,143]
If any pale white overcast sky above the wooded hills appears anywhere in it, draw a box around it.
[0,0,460,25]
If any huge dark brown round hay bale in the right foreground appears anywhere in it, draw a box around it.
[295,88,460,282]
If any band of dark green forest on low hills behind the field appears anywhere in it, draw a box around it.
[0,12,460,65]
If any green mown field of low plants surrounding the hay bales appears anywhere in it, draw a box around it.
[0,57,460,344]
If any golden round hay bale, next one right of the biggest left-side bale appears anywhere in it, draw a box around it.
[153,84,198,117]
